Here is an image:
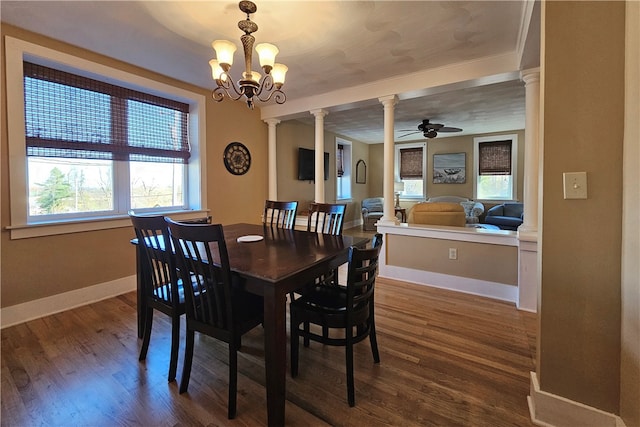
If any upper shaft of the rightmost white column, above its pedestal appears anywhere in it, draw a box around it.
[519,69,540,233]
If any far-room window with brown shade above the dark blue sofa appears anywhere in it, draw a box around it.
[473,135,518,200]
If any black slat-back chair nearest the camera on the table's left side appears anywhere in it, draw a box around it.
[167,219,264,419]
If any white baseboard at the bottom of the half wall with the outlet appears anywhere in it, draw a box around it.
[379,265,518,303]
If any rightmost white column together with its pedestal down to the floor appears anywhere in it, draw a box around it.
[516,69,540,312]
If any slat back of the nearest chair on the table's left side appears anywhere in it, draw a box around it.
[167,219,233,331]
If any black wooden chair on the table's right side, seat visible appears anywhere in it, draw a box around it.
[289,234,382,406]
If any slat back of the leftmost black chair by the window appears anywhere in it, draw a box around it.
[129,213,179,305]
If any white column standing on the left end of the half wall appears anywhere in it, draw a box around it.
[378,95,400,225]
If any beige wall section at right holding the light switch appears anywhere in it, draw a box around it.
[537,1,624,413]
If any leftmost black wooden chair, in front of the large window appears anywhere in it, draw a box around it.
[129,212,185,381]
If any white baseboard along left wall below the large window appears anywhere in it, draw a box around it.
[0,275,137,329]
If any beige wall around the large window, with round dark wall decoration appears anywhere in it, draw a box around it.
[0,24,267,307]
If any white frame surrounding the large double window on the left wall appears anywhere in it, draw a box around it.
[5,36,207,239]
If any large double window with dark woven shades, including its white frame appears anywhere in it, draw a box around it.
[5,37,205,238]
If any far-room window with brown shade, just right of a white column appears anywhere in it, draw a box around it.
[395,143,427,199]
